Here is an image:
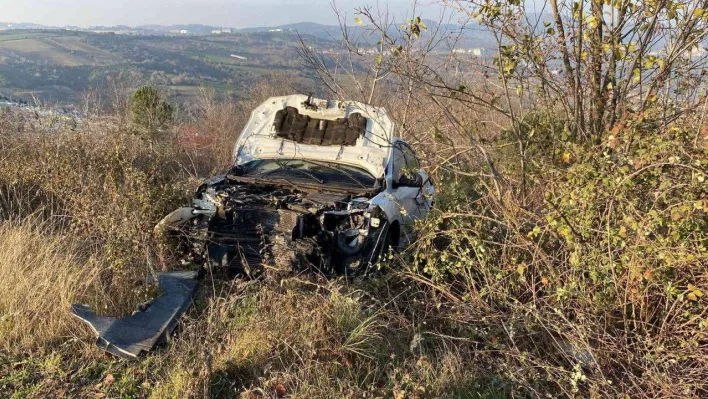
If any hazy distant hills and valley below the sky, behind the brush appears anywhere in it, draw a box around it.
[0,21,495,108]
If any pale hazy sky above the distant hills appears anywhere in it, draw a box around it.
[0,0,438,28]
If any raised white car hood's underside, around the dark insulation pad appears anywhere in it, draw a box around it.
[234,95,394,177]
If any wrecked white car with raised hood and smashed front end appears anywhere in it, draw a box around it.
[158,95,435,275]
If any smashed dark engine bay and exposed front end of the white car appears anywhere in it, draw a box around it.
[171,175,388,273]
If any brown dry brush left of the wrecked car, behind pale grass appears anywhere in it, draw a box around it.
[0,131,191,313]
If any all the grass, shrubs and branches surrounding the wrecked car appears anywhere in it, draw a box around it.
[0,2,708,399]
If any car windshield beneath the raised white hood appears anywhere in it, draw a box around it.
[237,159,377,190]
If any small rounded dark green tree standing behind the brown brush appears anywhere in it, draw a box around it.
[130,86,174,140]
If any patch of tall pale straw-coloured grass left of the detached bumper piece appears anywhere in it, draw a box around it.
[0,219,102,353]
